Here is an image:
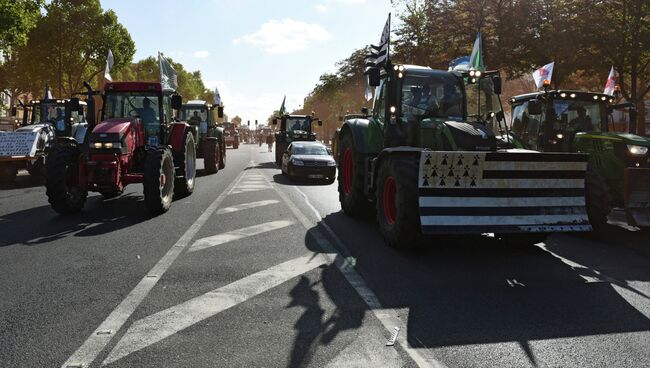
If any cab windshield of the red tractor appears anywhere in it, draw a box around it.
[104,92,161,141]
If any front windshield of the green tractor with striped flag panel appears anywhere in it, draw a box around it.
[402,75,463,121]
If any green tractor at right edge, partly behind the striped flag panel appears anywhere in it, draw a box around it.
[510,90,650,228]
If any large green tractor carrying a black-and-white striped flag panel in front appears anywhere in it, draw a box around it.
[334,62,591,248]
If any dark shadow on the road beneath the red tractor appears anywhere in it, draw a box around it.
[0,193,152,247]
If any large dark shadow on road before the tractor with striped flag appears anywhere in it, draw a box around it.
[298,212,650,366]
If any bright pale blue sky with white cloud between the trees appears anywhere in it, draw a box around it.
[102,0,392,125]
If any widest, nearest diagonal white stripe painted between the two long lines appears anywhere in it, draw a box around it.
[103,253,329,365]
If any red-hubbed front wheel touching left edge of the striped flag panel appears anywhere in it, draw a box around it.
[376,157,422,249]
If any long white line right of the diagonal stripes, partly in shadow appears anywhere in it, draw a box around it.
[256,171,446,368]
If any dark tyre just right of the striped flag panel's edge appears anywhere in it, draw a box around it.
[585,169,611,231]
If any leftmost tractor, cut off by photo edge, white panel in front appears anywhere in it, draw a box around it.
[0,90,88,183]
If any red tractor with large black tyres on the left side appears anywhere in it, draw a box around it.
[46,82,196,214]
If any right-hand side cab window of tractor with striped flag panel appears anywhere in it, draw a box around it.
[465,76,501,123]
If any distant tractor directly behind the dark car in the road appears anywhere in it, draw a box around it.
[273,114,323,165]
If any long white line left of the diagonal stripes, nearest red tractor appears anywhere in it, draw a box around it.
[62,171,244,368]
